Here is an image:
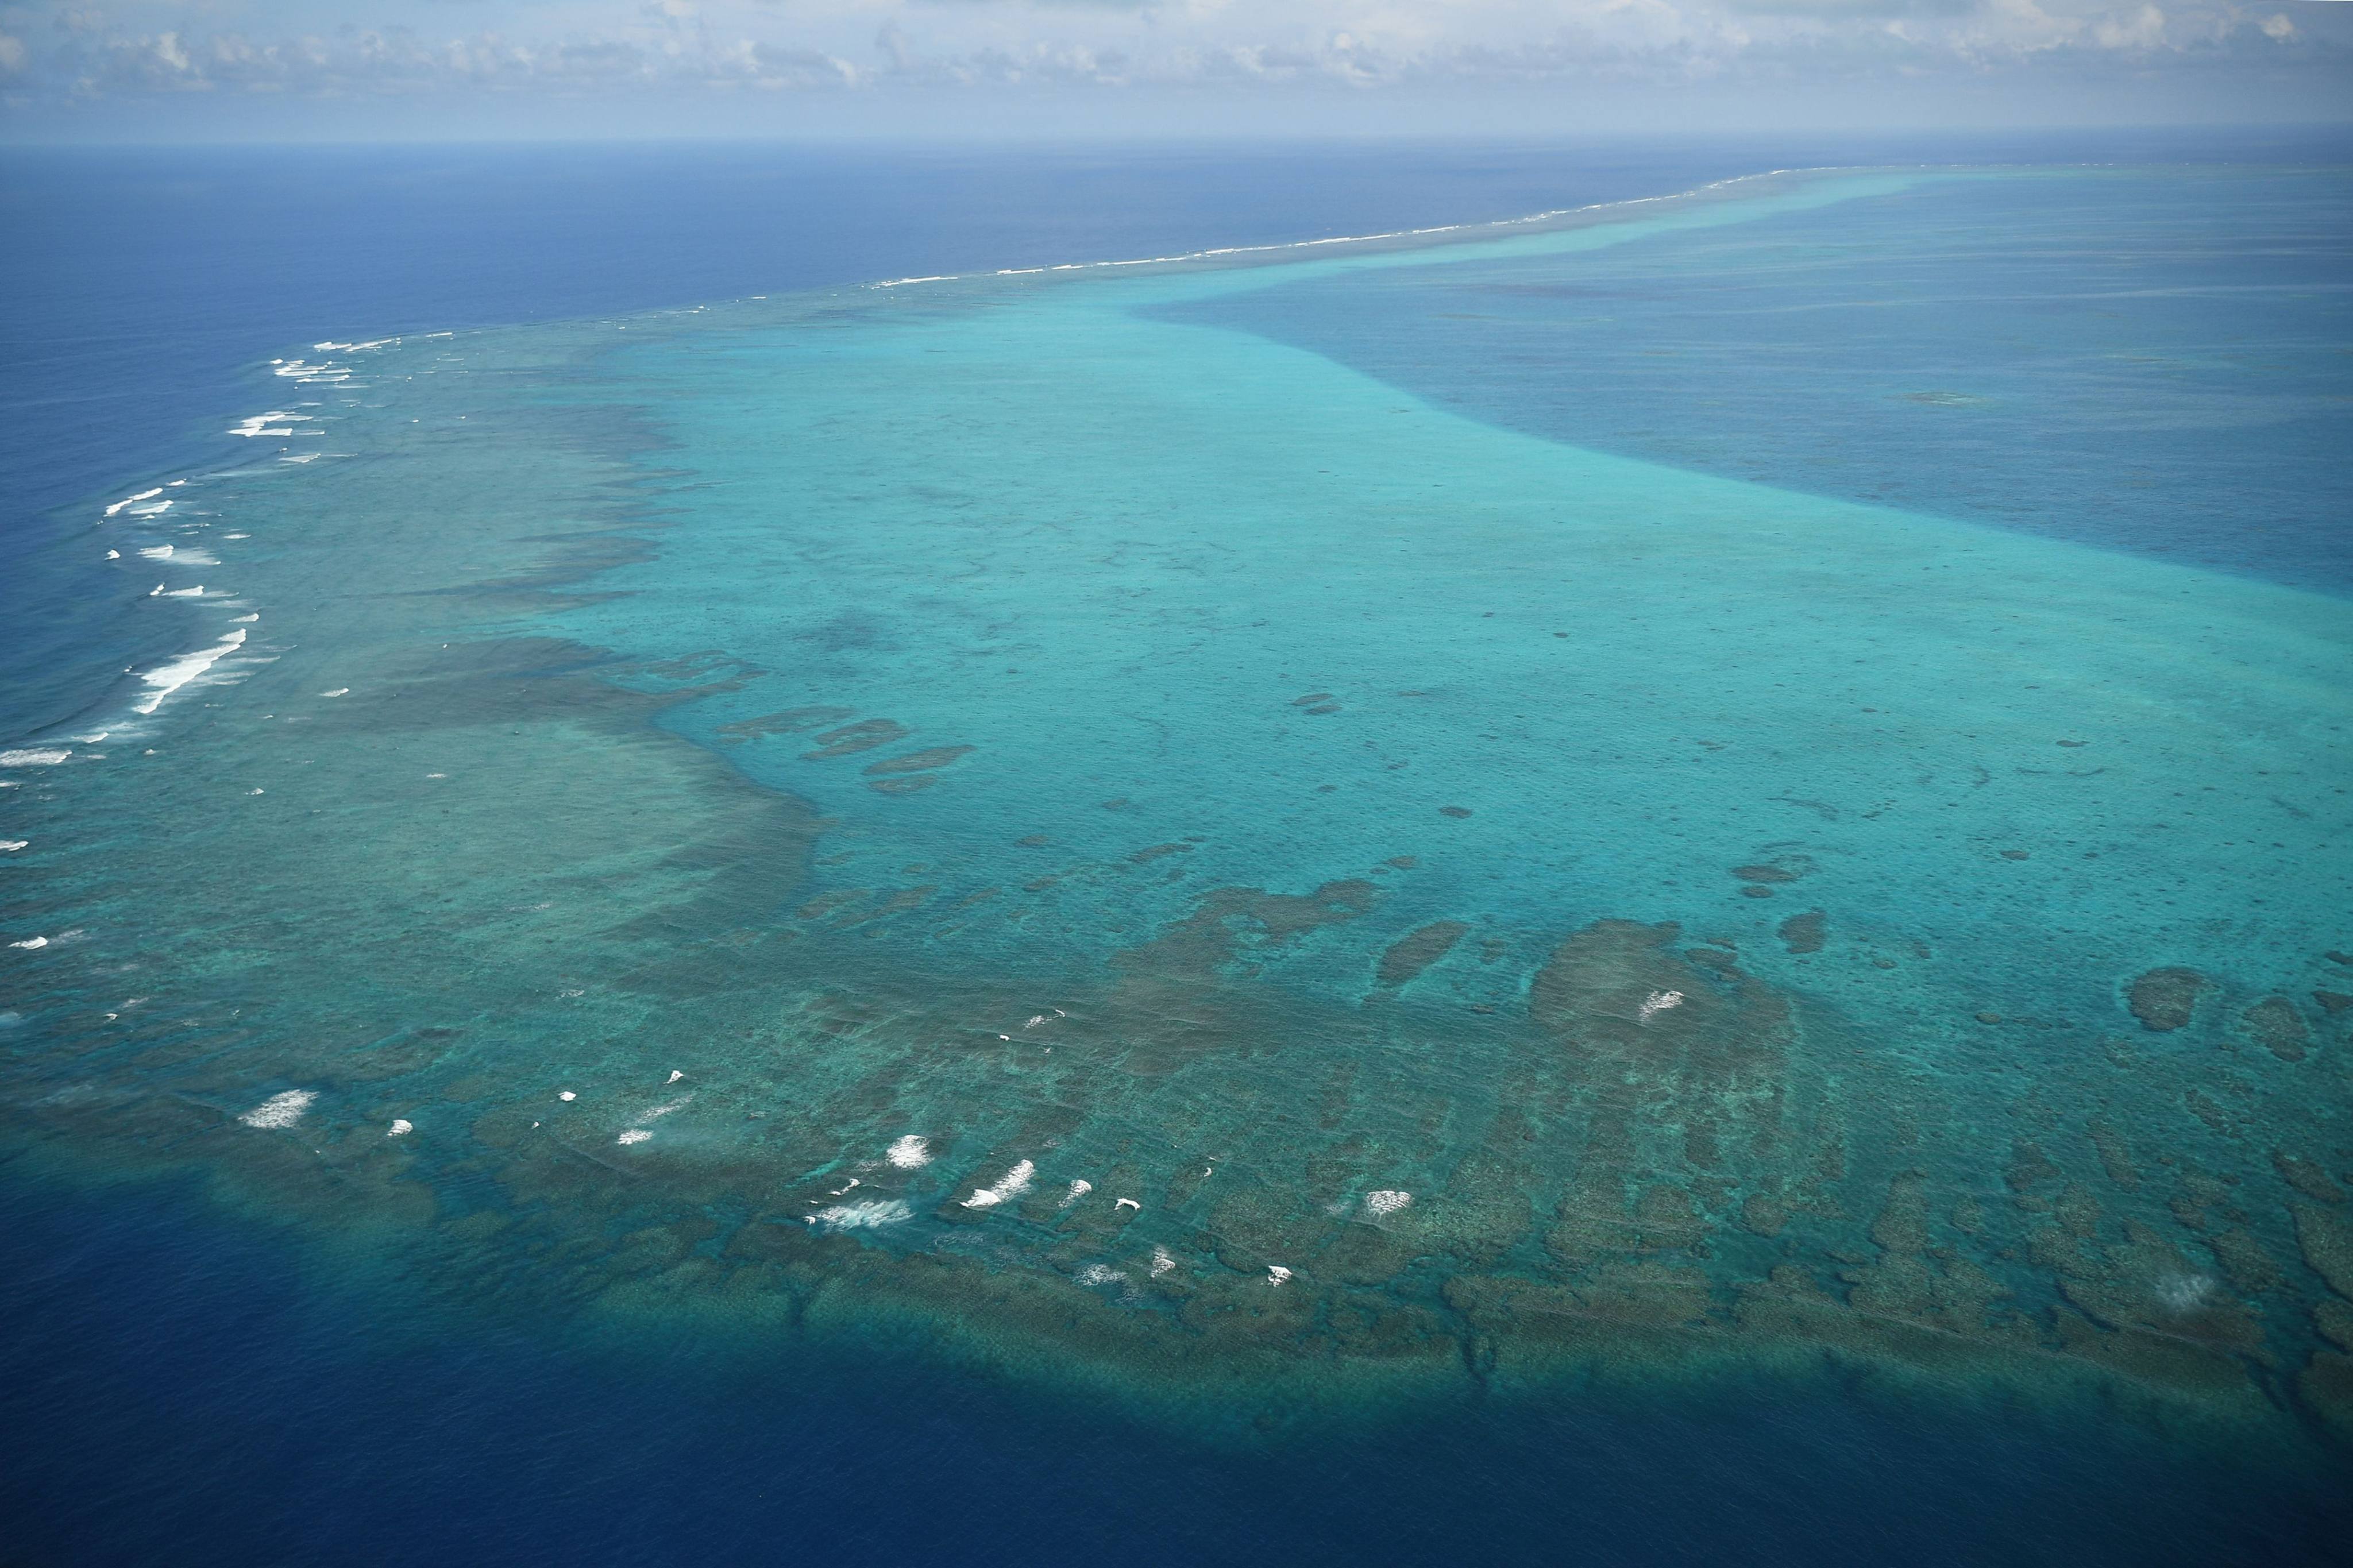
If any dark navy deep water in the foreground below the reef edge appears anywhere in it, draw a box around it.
[14,1189,2346,1566]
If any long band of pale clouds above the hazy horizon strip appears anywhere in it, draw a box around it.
[0,0,2353,115]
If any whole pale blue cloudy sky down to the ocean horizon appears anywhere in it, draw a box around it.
[0,0,2353,144]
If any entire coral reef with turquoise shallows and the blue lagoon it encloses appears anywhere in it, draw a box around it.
[0,169,2353,1465]
